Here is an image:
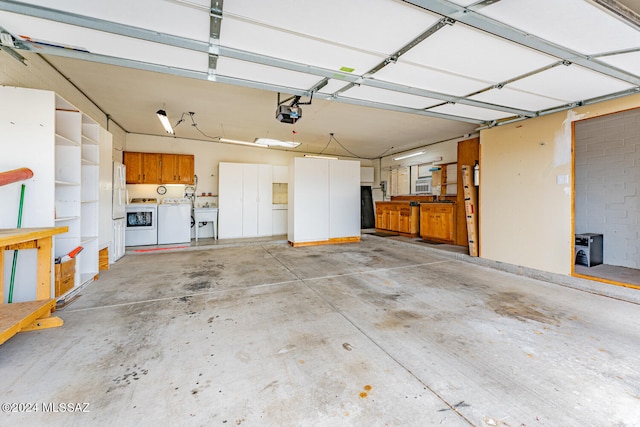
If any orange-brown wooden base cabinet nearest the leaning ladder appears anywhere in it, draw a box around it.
[420,203,456,244]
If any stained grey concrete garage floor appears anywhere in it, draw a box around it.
[0,235,640,427]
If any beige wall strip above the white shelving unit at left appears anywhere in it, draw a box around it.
[0,50,126,160]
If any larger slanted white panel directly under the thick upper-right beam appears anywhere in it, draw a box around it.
[402,23,558,83]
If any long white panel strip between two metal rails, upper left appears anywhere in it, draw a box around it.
[0,12,209,73]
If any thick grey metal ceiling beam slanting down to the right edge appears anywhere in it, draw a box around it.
[403,0,640,86]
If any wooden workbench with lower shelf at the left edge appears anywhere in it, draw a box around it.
[0,227,69,344]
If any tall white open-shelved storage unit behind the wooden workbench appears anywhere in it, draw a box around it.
[0,87,105,302]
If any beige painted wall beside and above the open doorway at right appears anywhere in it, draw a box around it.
[480,95,640,274]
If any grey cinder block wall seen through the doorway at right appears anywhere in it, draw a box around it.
[575,109,640,268]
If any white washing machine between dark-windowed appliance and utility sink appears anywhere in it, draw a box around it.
[158,197,191,245]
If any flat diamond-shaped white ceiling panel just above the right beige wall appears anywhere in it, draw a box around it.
[509,64,633,102]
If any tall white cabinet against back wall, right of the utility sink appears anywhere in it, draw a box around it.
[218,163,273,239]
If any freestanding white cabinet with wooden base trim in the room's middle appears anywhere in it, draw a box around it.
[288,157,360,246]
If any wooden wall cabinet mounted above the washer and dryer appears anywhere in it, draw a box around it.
[123,151,194,185]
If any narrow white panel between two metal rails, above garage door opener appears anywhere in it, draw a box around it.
[216,57,320,90]
